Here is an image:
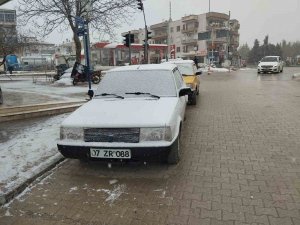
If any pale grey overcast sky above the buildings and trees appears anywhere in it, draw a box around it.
[2,0,300,46]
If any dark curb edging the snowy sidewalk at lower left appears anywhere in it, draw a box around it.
[0,157,65,207]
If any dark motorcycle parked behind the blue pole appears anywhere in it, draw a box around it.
[71,63,101,86]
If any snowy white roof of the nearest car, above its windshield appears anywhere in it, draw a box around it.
[109,64,176,72]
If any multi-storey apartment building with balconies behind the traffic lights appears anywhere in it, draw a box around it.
[127,12,240,65]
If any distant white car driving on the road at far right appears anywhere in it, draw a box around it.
[257,56,283,73]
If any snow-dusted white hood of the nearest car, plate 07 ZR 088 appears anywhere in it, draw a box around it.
[62,97,178,128]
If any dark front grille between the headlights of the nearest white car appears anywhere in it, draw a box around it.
[84,128,140,143]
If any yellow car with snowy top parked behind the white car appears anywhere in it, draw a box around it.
[165,60,202,105]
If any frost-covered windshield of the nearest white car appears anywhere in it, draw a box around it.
[95,70,177,98]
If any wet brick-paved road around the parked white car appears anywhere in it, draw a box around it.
[0,68,300,225]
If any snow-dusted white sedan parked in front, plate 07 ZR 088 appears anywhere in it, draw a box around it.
[57,64,191,164]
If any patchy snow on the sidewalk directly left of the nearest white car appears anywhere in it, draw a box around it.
[0,114,67,195]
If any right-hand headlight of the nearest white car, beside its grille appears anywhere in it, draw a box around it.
[140,127,172,142]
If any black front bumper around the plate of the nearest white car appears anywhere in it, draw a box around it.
[57,144,172,161]
